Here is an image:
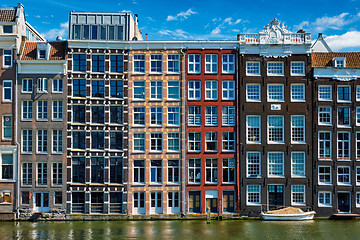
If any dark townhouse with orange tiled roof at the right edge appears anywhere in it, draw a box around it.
[312,52,360,216]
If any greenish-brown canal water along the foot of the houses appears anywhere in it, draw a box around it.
[0,220,360,240]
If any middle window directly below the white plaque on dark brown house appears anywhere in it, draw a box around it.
[268,116,284,144]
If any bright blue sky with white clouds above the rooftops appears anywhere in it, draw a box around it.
[0,0,360,51]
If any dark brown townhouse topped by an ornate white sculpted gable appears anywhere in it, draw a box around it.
[237,19,313,216]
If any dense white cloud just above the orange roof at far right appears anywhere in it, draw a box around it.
[325,31,360,51]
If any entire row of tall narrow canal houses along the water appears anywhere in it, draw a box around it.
[0,5,360,218]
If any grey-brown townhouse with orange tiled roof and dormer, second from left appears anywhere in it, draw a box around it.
[16,41,67,219]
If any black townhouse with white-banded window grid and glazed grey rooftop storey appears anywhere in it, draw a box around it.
[66,12,142,217]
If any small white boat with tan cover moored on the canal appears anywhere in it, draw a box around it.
[261,207,316,221]
